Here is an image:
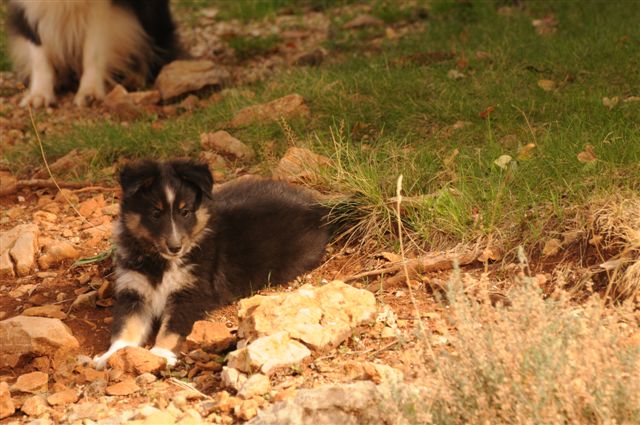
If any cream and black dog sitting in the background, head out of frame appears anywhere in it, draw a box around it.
[7,0,180,107]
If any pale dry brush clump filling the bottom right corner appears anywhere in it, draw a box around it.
[402,274,640,424]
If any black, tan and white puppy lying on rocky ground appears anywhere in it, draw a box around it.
[94,160,329,368]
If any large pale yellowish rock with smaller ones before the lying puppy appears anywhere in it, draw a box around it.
[222,281,376,397]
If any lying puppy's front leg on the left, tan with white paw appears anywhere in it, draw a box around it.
[93,291,153,370]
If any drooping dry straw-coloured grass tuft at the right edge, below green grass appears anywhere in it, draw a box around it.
[589,194,640,299]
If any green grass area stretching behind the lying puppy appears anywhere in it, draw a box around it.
[9,2,640,252]
